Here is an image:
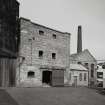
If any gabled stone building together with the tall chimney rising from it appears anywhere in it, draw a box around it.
[70,26,97,87]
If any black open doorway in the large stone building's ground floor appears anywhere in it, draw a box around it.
[42,71,52,85]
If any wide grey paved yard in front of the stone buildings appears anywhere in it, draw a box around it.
[6,87,105,105]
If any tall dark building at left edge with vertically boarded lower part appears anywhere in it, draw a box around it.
[0,0,19,87]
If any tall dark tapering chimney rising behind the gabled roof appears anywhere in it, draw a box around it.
[77,26,82,53]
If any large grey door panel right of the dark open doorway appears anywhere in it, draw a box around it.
[52,70,64,86]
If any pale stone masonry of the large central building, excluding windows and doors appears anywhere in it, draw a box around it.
[17,18,70,86]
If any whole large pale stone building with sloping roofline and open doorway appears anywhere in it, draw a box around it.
[16,18,70,87]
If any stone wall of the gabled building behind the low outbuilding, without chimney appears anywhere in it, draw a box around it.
[70,49,97,86]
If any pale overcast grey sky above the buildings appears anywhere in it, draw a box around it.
[18,0,105,60]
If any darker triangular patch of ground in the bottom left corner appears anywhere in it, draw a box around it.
[0,89,18,105]
